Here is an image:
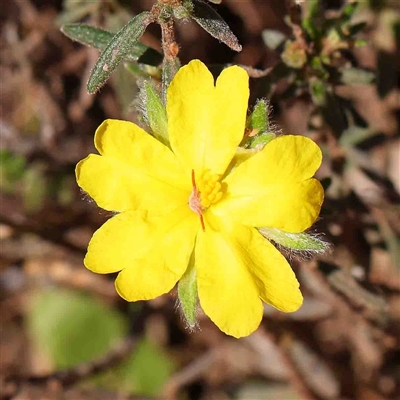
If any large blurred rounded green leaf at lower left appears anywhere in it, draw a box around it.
[28,289,127,369]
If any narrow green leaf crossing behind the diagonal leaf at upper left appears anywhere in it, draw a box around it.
[61,24,162,66]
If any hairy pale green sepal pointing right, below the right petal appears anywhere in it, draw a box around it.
[259,228,329,253]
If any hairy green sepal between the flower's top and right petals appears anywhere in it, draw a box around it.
[245,99,275,149]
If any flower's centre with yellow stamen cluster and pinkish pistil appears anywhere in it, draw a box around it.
[189,170,223,230]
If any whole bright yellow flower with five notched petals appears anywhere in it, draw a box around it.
[76,60,323,337]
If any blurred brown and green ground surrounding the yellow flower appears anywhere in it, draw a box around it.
[0,0,400,400]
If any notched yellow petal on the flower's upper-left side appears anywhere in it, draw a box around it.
[76,120,191,211]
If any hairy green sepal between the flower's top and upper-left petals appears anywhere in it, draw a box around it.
[141,81,169,146]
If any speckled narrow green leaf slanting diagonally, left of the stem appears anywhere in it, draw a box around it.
[87,12,152,93]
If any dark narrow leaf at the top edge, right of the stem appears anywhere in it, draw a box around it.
[192,0,242,51]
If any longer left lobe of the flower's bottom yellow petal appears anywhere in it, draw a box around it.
[195,212,263,338]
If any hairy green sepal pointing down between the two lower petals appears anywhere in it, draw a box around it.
[178,254,198,329]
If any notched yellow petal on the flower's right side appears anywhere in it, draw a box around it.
[214,135,324,233]
